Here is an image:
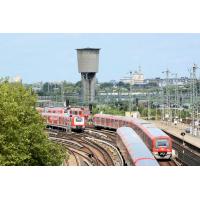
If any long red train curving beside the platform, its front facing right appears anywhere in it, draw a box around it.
[93,114,172,159]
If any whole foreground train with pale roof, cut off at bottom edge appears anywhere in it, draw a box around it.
[116,127,159,166]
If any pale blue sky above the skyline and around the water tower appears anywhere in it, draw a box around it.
[0,33,200,83]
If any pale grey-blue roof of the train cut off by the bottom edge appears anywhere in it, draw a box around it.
[117,127,159,166]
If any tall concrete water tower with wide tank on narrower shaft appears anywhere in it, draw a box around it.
[76,48,100,103]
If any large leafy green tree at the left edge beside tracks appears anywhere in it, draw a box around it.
[0,82,68,166]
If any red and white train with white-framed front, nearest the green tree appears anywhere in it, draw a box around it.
[42,113,85,132]
